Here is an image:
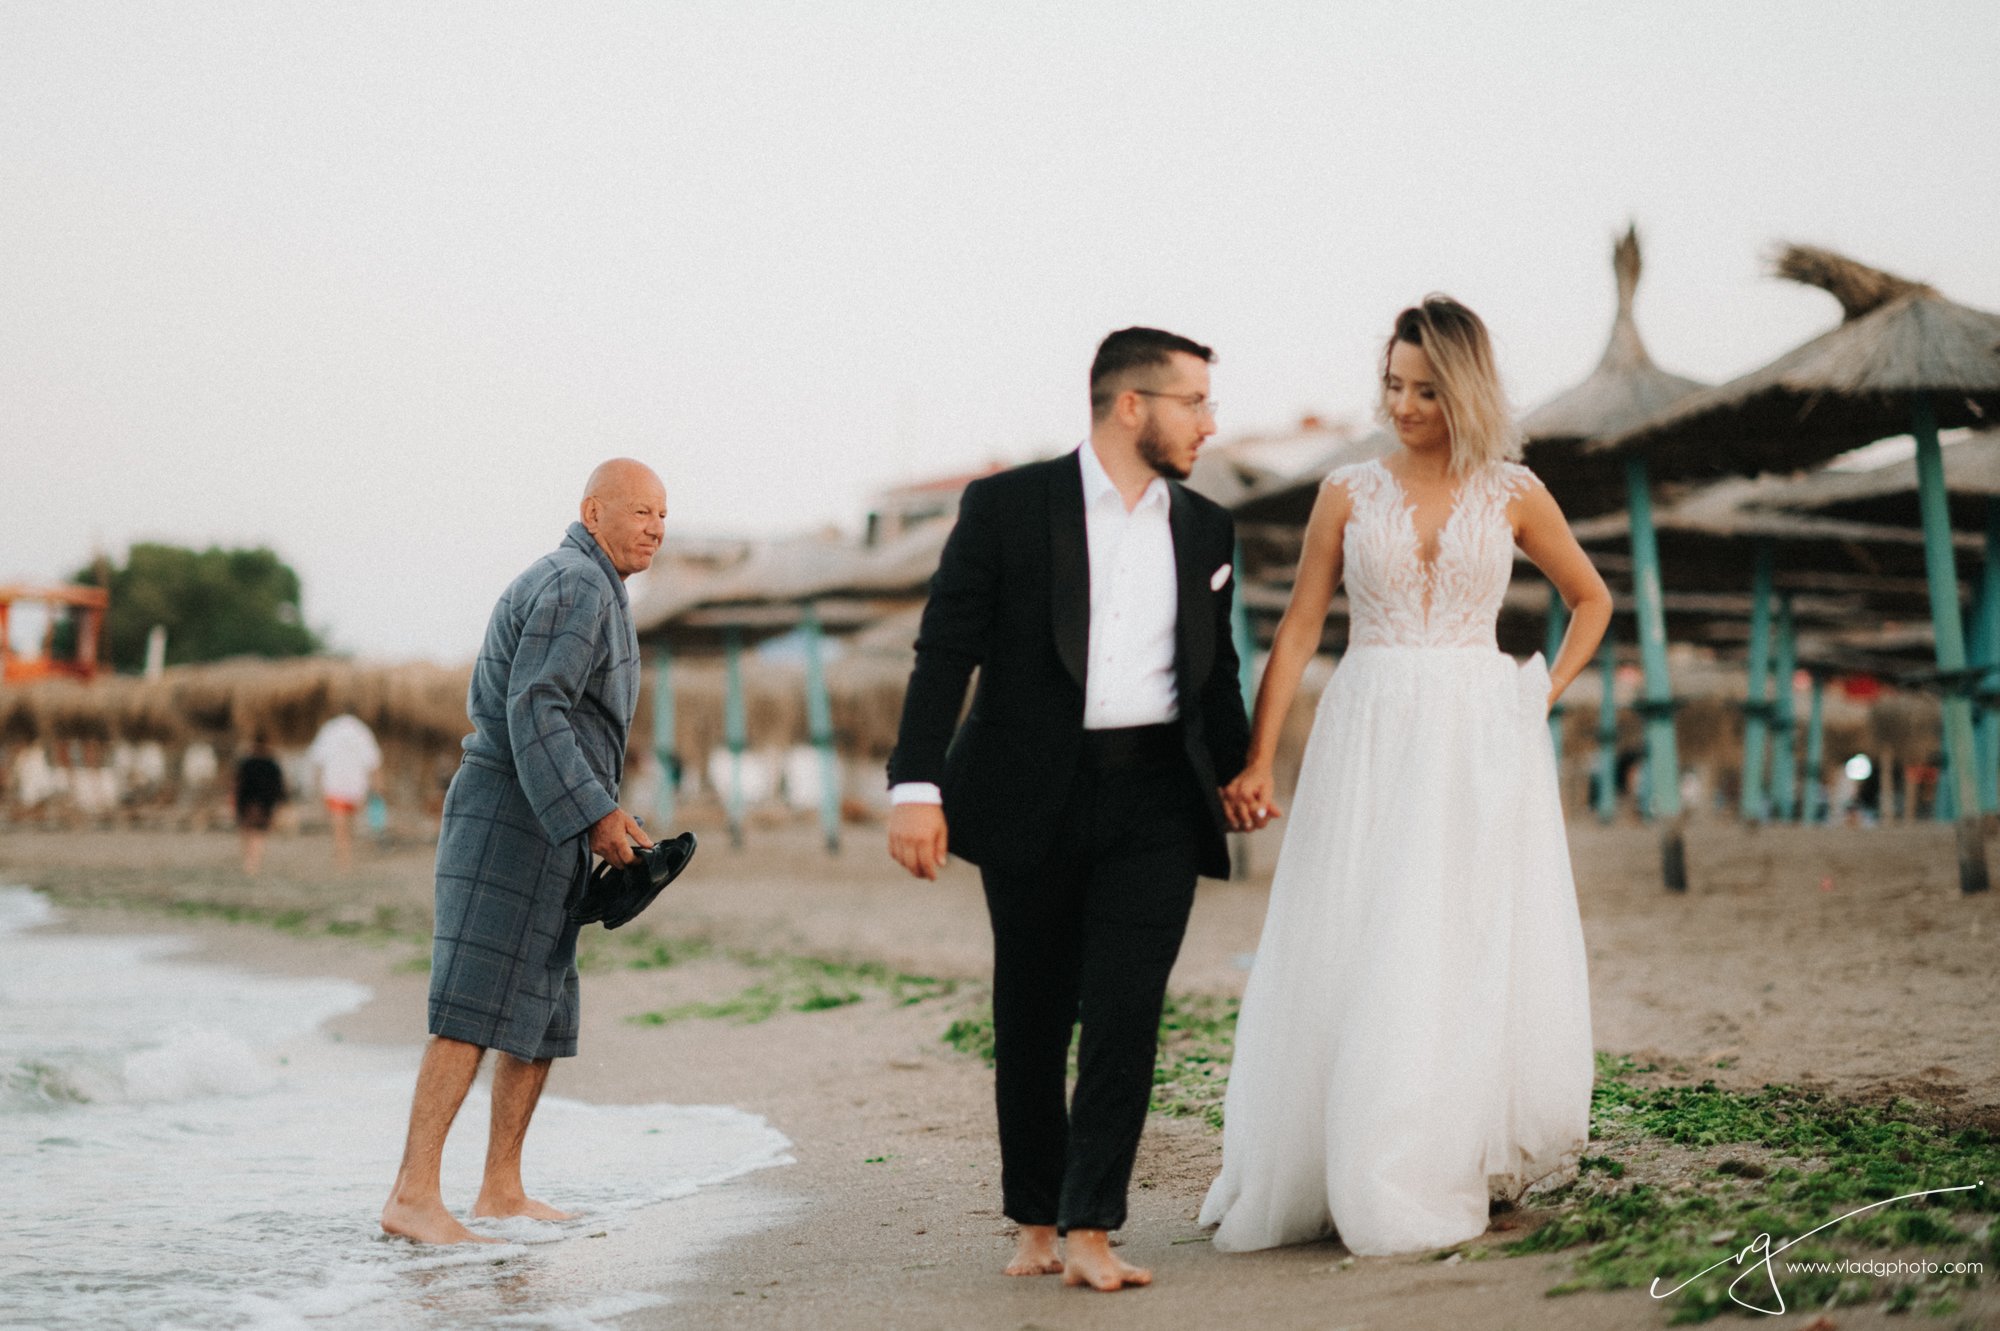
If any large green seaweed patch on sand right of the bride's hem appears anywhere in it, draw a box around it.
[1504,1053,2000,1323]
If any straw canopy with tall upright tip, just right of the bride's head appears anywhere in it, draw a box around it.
[1520,226,1704,518]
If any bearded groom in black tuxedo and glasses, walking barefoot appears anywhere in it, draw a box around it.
[888,328,1250,1289]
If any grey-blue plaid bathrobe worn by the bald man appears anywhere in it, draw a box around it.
[430,522,640,1059]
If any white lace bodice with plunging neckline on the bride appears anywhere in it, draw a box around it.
[1324,460,1536,648]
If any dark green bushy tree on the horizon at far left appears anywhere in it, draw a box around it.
[76,544,320,671]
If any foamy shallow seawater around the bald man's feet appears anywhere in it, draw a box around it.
[0,887,790,1331]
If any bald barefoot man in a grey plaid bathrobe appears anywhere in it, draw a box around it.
[382,458,666,1243]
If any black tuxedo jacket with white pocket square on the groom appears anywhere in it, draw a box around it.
[888,444,1250,877]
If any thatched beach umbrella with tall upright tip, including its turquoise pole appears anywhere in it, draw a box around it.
[1522,226,1702,891]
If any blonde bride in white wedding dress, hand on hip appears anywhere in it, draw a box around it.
[1202,296,1612,1255]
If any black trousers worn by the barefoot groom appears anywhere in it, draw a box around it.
[982,725,1208,1233]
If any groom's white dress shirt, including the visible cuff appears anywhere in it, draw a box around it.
[888,442,1180,803]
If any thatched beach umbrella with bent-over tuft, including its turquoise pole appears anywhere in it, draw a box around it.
[1592,246,2000,891]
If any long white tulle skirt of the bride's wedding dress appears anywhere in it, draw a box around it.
[1202,648,1592,1255]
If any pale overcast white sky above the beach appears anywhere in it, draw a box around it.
[0,0,2000,660]
